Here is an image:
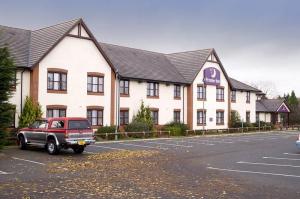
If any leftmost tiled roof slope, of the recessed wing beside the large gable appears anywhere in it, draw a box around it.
[0,25,31,67]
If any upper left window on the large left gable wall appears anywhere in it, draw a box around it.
[47,71,67,91]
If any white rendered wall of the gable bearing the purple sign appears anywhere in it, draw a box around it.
[193,62,229,129]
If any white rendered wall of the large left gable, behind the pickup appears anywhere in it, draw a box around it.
[38,37,111,125]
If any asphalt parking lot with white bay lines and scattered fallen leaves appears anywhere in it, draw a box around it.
[0,132,300,198]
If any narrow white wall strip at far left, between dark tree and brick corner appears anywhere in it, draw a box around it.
[9,70,30,127]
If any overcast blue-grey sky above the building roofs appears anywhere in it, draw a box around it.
[0,0,300,96]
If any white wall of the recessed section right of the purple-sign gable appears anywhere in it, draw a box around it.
[231,91,256,123]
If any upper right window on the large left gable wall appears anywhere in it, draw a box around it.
[87,73,104,93]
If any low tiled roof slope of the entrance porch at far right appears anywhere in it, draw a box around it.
[256,99,284,112]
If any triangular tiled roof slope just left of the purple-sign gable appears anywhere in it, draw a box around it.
[166,49,213,83]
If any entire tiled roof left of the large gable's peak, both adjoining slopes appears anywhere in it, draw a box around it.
[0,19,81,67]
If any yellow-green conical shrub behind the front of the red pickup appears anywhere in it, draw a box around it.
[19,96,43,128]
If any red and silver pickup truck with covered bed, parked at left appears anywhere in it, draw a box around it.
[17,117,95,155]
